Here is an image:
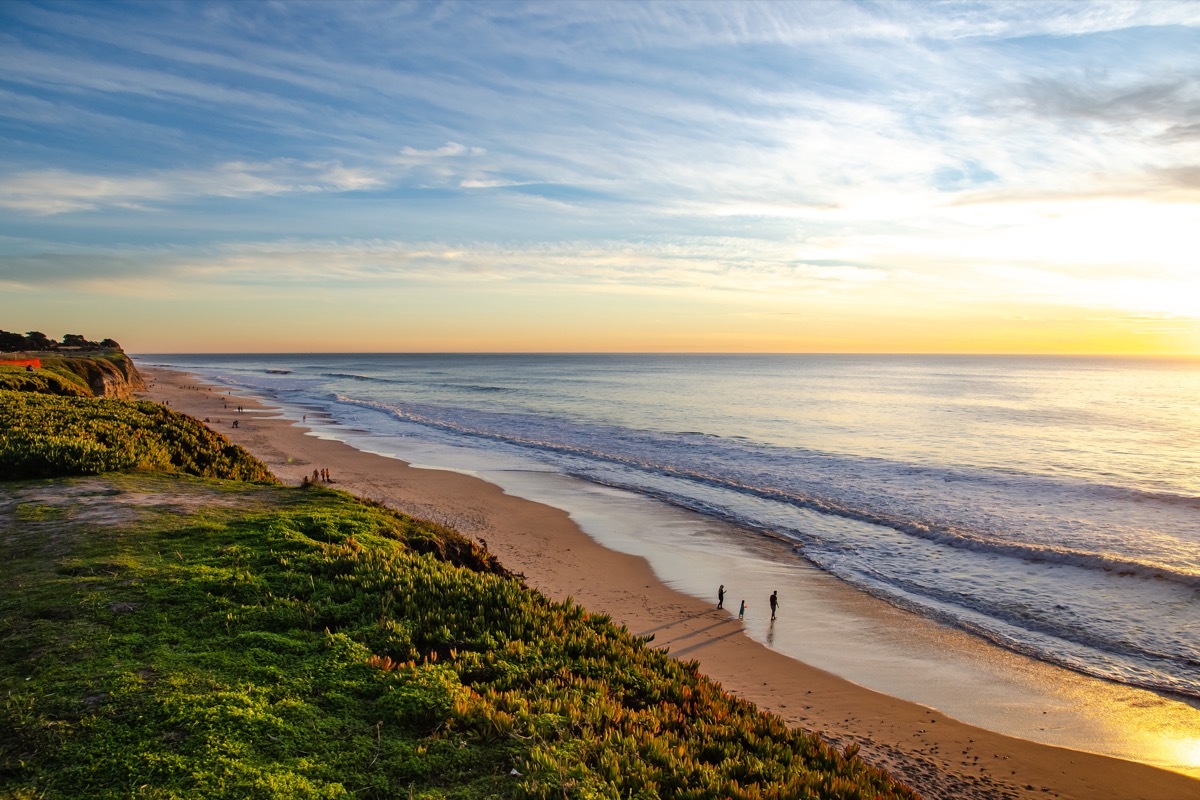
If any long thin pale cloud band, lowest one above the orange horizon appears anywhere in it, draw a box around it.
[0,237,886,294]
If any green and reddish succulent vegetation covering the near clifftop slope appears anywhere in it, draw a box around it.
[0,392,917,800]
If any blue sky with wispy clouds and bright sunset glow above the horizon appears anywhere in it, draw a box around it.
[0,0,1200,355]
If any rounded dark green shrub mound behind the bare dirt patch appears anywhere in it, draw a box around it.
[0,391,275,482]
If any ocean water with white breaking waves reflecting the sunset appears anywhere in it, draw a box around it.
[139,354,1200,703]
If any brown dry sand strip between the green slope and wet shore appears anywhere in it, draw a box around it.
[143,368,1200,800]
